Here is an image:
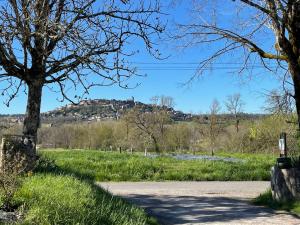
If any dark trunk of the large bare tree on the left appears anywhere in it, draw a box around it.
[23,83,43,143]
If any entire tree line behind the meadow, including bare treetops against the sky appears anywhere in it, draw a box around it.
[1,92,297,155]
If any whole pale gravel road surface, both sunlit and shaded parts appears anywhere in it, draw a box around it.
[99,181,300,225]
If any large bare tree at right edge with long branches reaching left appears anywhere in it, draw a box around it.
[176,0,300,128]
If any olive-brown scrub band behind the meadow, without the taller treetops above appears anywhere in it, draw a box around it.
[34,112,297,154]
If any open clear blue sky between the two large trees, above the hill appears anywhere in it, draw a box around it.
[0,0,281,114]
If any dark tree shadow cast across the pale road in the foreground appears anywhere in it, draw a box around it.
[119,195,300,225]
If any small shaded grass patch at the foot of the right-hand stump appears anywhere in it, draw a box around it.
[253,189,300,216]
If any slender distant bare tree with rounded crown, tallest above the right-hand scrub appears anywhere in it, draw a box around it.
[225,93,244,132]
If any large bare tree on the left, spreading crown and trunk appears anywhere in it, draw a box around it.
[0,0,164,151]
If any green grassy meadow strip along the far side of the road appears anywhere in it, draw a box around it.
[41,150,275,181]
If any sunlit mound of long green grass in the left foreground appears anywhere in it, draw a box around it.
[14,174,155,225]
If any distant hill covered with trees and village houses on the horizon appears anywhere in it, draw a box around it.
[0,99,265,123]
